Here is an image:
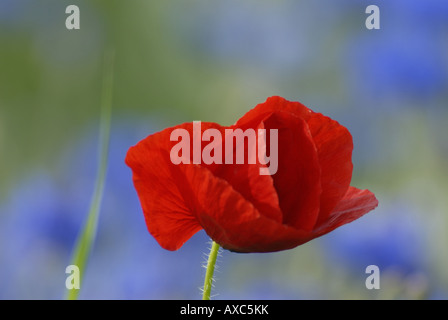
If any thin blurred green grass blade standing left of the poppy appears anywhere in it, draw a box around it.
[67,52,113,300]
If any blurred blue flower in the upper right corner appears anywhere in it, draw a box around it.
[342,1,448,109]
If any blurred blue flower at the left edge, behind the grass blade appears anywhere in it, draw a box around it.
[0,174,85,299]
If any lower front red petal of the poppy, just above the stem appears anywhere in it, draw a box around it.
[191,166,312,252]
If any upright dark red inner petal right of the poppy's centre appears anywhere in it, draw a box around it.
[236,96,322,231]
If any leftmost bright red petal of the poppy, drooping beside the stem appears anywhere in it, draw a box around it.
[125,123,220,250]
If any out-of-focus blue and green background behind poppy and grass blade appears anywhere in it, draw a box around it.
[0,0,448,299]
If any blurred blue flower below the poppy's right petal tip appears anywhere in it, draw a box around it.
[322,203,428,276]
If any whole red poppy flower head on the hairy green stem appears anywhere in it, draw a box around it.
[126,97,378,252]
